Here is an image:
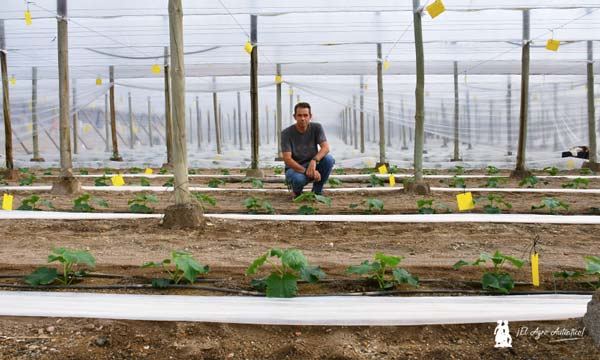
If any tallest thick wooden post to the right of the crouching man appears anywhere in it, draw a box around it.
[413,0,430,194]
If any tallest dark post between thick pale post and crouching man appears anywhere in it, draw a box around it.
[246,15,268,177]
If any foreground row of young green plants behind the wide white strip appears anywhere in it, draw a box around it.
[18,248,600,298]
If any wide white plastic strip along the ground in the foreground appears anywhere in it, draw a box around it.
[0,291,591,326]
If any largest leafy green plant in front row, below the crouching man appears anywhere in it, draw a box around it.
[246,249,325,298]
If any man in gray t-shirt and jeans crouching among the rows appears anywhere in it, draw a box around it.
[281,102,335,198]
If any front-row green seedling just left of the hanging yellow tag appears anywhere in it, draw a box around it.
[452,251,525,294]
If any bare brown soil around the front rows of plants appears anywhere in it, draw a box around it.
[0,171,600,359]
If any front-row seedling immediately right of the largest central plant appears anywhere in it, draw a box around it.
[346,252,419,289]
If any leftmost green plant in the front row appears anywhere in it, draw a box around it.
[25,248,96,286]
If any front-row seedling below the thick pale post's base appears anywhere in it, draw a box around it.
[141,251,210,288]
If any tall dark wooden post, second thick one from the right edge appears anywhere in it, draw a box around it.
[511,10,530,178]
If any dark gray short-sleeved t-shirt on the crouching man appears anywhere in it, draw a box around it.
[281,122,327,164]
